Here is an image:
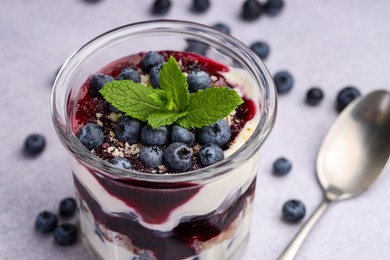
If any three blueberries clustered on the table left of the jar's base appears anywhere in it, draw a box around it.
[35,197,78,246]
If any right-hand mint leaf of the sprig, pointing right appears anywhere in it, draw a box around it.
[177,87,244,128]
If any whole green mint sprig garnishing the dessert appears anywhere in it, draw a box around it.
[100,56,243,128]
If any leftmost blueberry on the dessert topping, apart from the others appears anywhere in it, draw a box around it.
[77,123,104,150]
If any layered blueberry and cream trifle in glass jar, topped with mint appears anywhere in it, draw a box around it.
[53,21,275,259]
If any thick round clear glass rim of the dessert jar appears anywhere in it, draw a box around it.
[51,20,277,184]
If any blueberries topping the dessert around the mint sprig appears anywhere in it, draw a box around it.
[77,51,231,172]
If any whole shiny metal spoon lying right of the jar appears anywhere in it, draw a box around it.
[278,90,390,260]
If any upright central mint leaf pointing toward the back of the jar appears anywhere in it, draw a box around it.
[160,56,189,111]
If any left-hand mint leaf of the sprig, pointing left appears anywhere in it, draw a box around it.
[99,80,165,121]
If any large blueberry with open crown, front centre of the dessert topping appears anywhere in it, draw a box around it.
[163,142,192,172]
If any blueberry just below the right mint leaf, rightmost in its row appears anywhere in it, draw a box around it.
[196,119,231,147]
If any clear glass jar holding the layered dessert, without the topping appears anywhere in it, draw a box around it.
[52,21,276,260]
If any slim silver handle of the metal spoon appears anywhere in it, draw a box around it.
[278,198,330,260]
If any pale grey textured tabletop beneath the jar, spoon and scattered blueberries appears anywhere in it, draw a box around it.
[0,0,390,260]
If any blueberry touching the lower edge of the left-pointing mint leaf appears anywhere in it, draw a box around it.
[115,116,142,144]
